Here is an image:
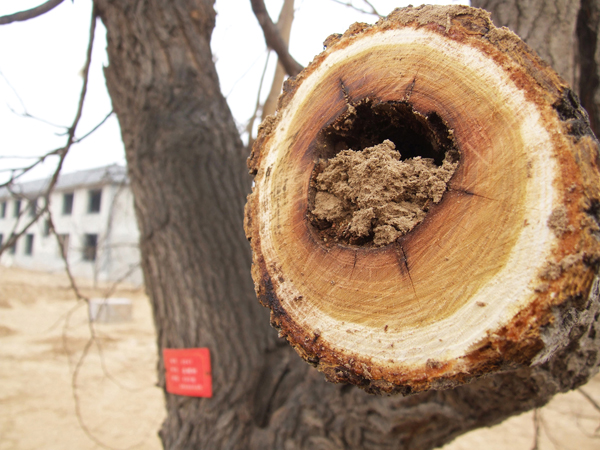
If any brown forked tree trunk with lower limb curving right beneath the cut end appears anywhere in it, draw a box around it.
[96,0,600,450]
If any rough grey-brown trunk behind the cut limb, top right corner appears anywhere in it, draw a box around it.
[471,0,600,136]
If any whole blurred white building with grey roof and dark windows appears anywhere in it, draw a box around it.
[0,165,142,284]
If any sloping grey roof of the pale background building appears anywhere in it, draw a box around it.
[0,164,128,199]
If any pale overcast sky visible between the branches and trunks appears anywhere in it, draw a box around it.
[0,0,469,182]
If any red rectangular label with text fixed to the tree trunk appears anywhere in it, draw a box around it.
[163,348,212,397]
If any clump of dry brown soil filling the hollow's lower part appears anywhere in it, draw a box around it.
[312,140,458,246]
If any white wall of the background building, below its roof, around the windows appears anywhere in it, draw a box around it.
[0,179,143,285]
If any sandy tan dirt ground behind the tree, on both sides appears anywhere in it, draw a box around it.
[0,267,600,450]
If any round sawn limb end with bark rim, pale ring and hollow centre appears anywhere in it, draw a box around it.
[245,6,600,394]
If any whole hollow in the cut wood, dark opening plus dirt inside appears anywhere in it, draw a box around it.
[309,102,459,247]
